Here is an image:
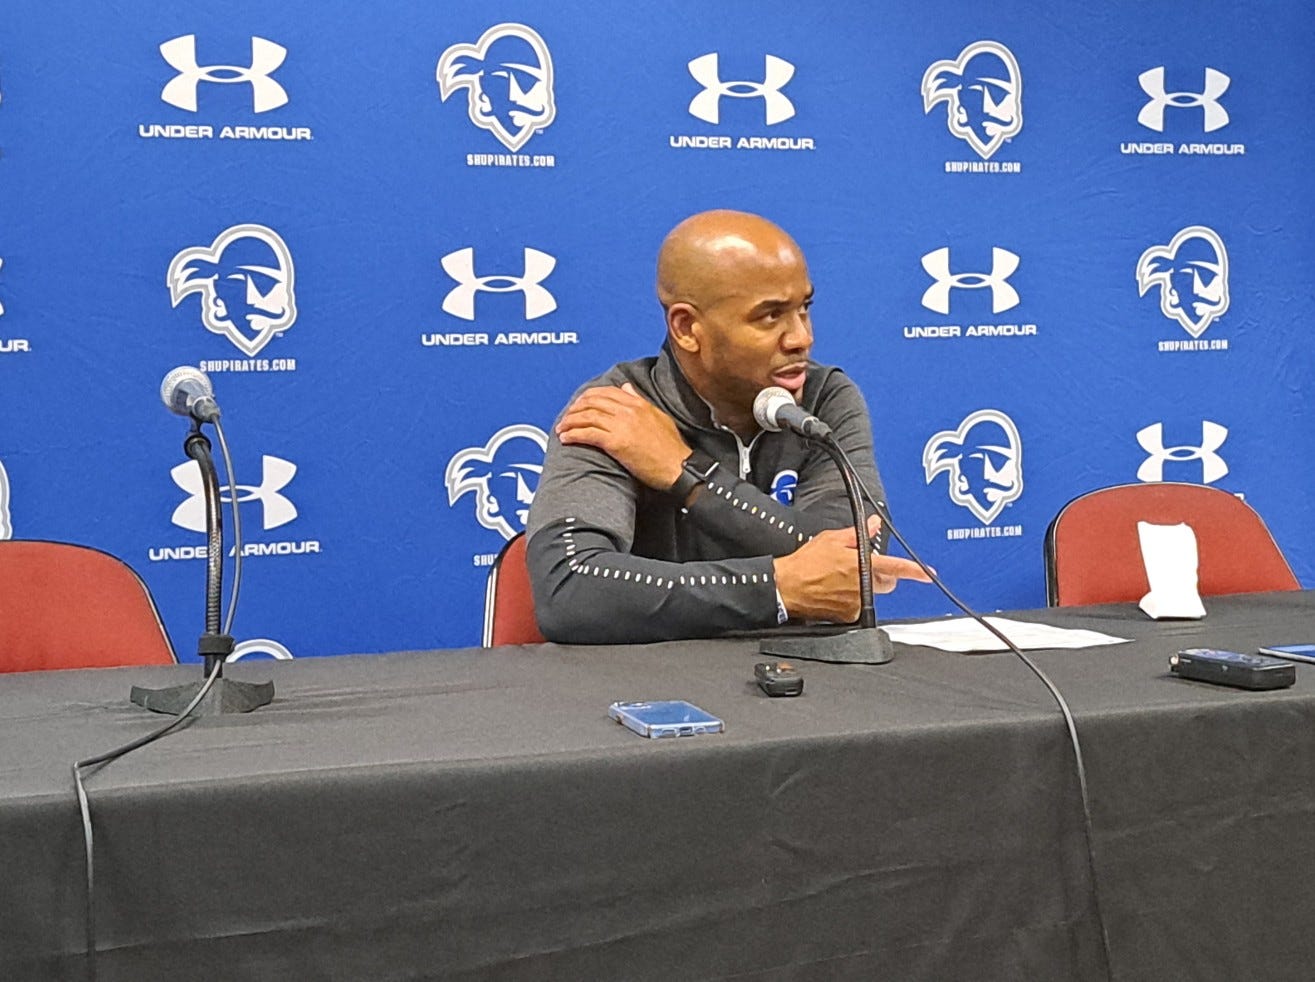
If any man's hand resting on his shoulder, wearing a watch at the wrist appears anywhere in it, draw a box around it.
[556,383,690,492]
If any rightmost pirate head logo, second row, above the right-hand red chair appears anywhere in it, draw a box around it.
[1137,225,1228,338]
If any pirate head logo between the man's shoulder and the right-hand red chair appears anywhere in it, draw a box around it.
[922,409,1023,525]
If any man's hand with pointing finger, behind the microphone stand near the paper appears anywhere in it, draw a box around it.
[773,515,931,623]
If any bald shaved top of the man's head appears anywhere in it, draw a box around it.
[658,210,803,308]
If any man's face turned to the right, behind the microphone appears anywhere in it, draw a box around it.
[696,246,813,413]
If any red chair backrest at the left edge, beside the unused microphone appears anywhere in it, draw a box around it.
[0,539,176,672]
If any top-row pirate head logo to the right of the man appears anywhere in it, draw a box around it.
[922,41,1023,160]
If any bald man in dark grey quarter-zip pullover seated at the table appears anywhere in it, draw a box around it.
[527,212,926,643]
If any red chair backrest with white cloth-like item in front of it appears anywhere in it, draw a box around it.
[1045,481,1302,607]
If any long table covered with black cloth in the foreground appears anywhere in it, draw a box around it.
[0,593,1315,982]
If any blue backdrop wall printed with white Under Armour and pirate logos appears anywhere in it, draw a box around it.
[0,0,1315,655]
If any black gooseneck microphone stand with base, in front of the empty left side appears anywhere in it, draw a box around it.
[129,421,274,716]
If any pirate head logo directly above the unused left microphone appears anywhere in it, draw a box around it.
[167,225,297,355]
